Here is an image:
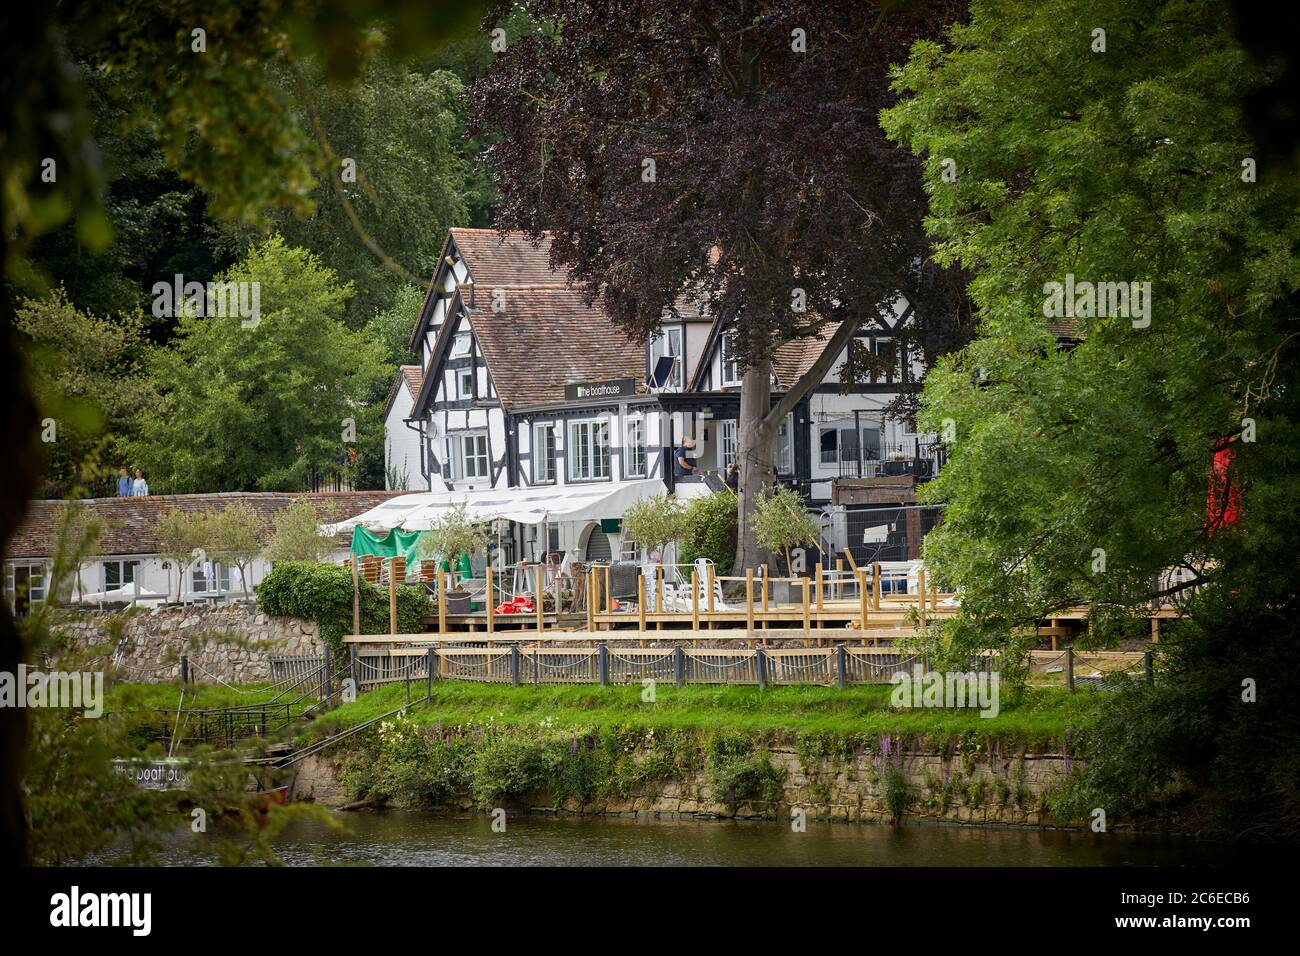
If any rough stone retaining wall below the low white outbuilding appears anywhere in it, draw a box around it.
[53,604,321,684]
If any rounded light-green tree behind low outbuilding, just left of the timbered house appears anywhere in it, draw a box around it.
[135,237,384,493]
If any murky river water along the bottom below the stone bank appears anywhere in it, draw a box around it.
[244,812,1238,866]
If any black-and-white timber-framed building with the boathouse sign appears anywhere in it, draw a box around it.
[385,229,939,559]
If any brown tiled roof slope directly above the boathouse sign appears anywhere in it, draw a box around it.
[468,285,646,408]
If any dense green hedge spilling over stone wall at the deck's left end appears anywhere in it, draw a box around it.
[257,561,437,659]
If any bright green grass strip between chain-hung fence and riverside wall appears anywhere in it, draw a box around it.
[316,682,1105,744]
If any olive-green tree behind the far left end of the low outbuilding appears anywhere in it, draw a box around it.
[17,289,156,497]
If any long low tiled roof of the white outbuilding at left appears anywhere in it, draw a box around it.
[5,492,407,558]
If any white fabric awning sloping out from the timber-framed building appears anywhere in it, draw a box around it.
[321,479,667,535]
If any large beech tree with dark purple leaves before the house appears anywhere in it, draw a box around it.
[469,0,969,567]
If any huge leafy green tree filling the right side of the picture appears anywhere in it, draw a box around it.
[884,0,1300,839]
